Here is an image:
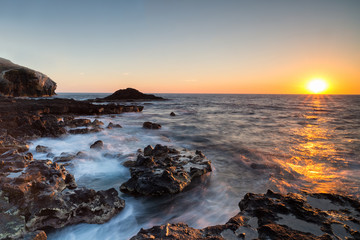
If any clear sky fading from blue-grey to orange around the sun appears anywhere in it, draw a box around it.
[0,0,360,94]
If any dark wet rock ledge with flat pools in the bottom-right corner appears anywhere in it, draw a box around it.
[131,190,360,240]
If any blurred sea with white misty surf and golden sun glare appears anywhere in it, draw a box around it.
[30,93,360,240]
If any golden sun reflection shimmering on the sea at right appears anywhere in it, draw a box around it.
[271,96,348,193]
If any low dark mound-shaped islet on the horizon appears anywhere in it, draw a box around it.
[94,88,165,102]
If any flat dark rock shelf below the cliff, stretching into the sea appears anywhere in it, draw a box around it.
[0,97,143,140]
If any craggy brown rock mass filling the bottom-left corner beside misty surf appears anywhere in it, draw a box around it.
[0,151,124,239]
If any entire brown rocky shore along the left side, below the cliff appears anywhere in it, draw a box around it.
[0,97,143,239]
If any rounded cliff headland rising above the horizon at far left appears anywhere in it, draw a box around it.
[0,58,56,97]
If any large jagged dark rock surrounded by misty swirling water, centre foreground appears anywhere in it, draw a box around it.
[120,144,212,195]
